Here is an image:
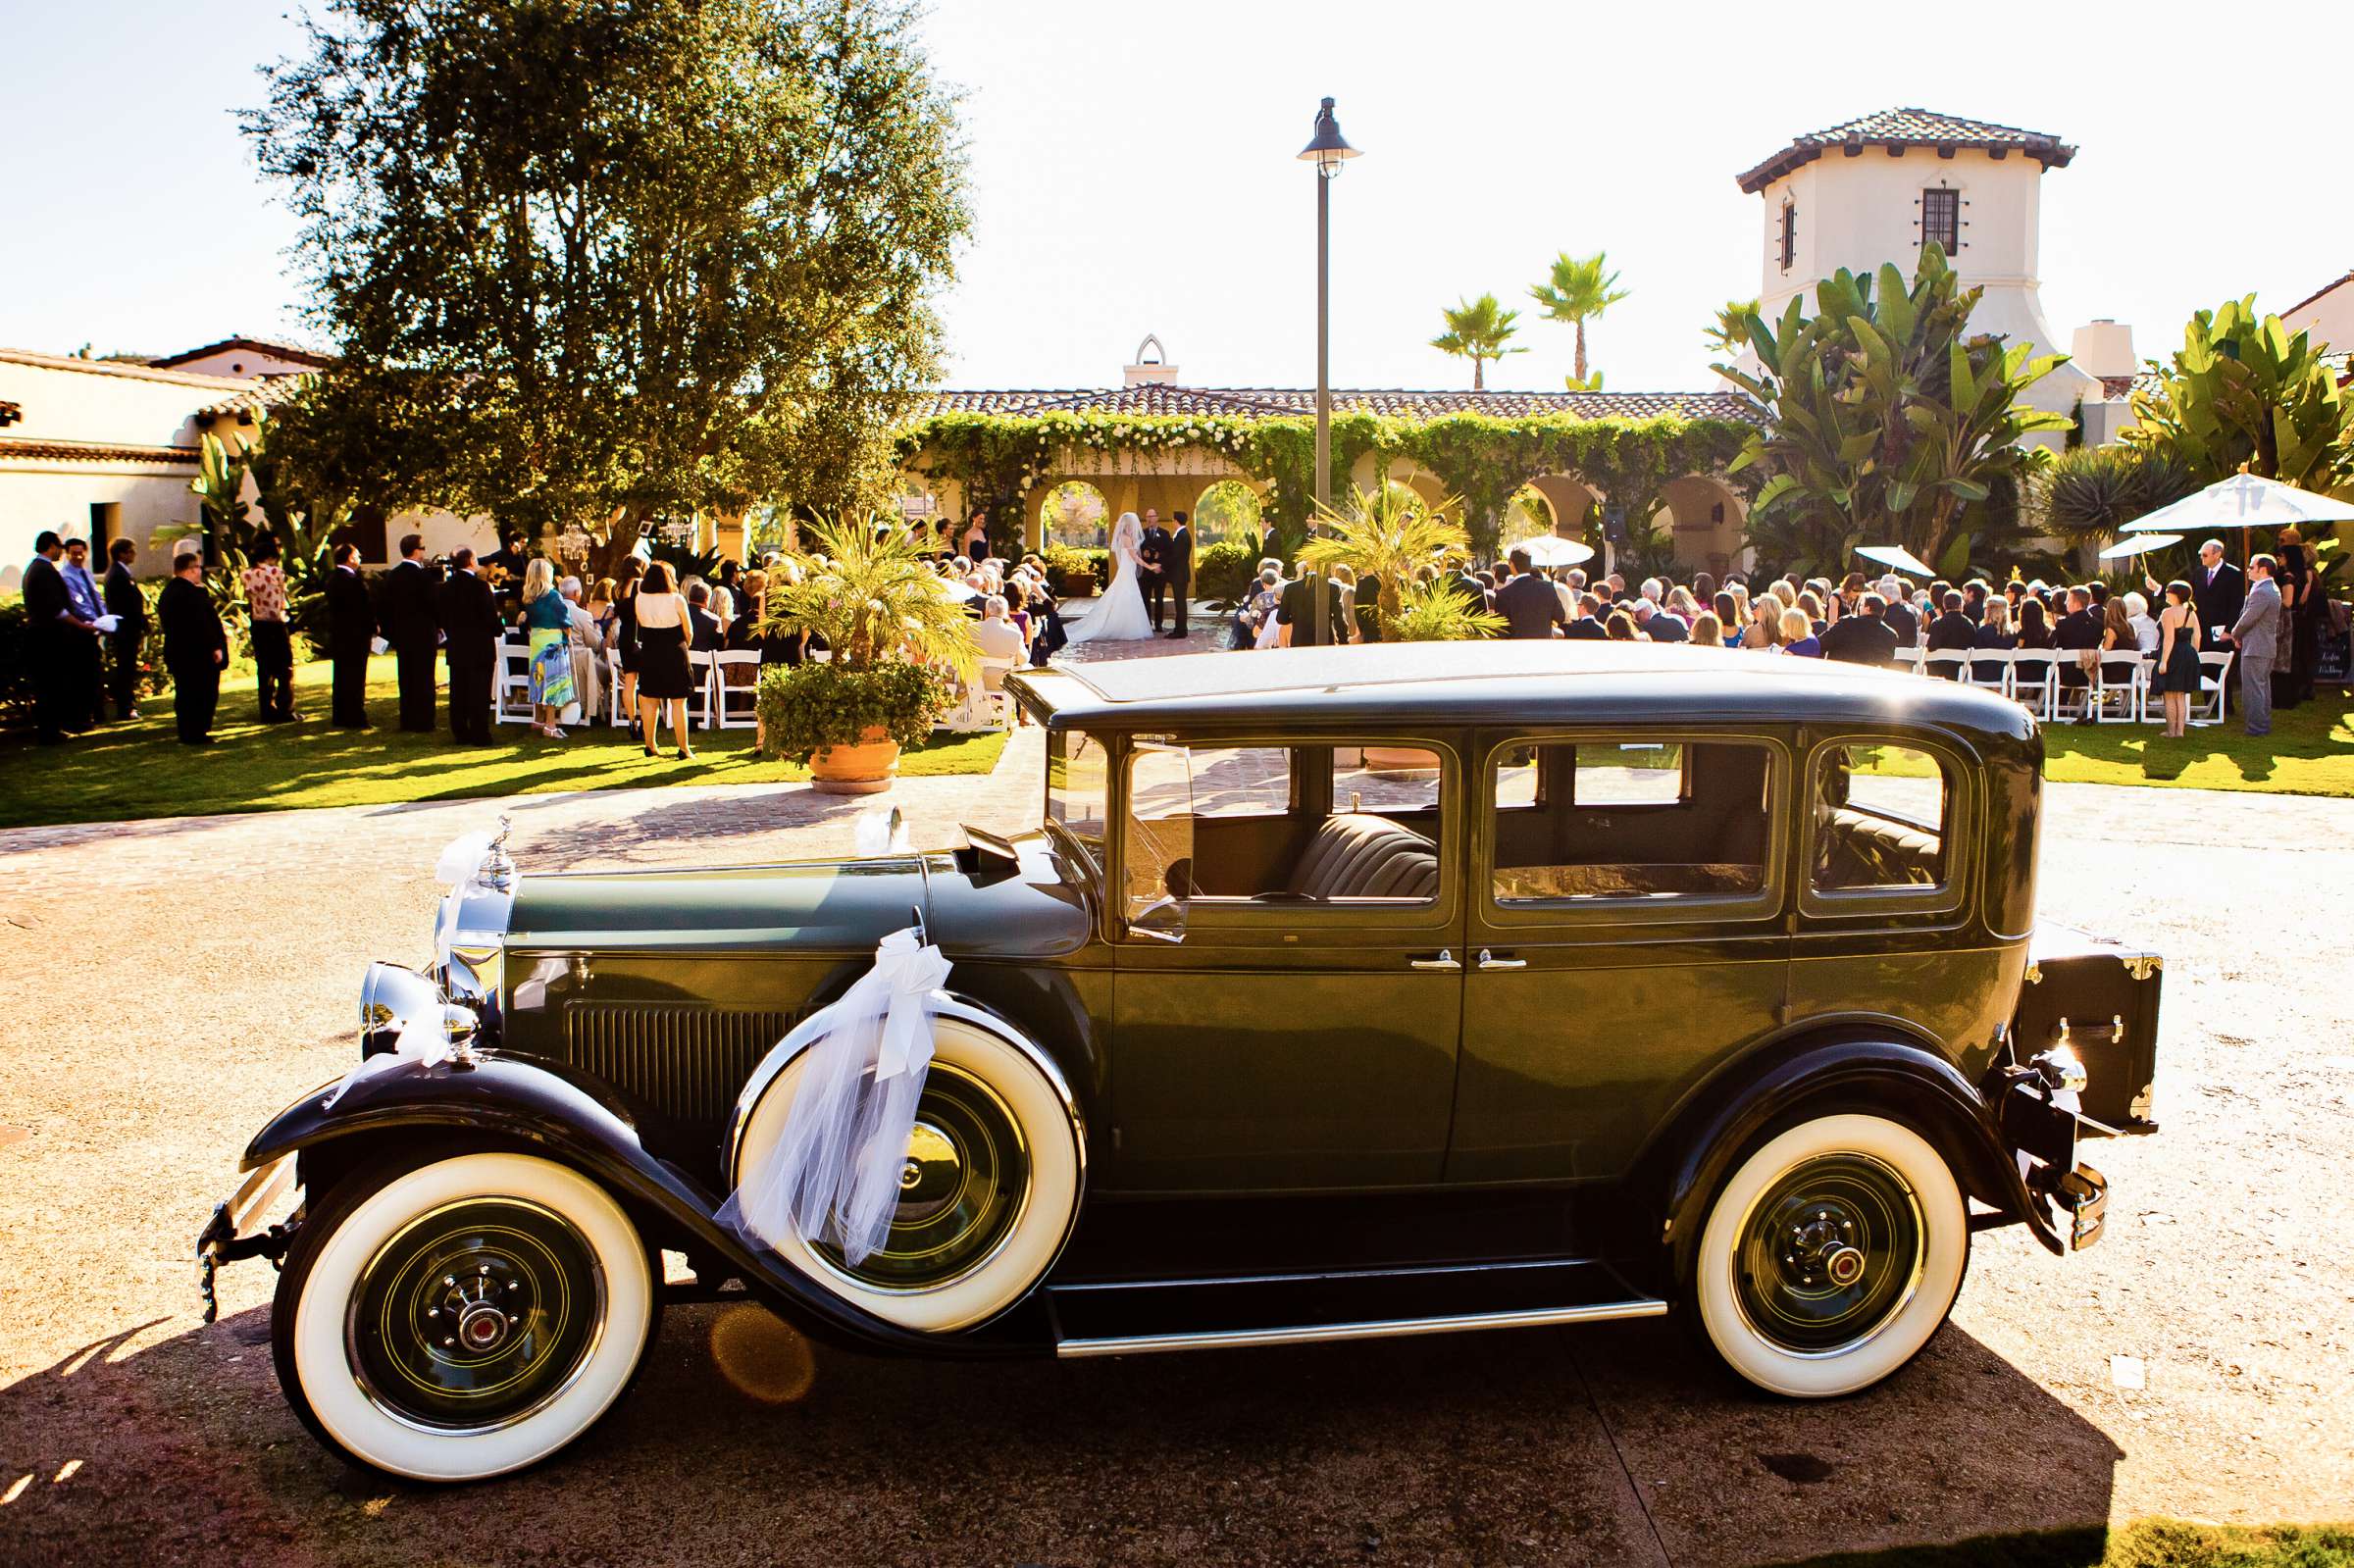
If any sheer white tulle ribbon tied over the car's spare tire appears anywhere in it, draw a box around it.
[720,928,948,1264]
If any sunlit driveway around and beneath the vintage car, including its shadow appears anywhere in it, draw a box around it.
[0,733,2354,1566]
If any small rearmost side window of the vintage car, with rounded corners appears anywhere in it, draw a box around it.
[1813,744,1954,892]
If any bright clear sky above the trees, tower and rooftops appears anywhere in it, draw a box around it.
[0,0,2354,391]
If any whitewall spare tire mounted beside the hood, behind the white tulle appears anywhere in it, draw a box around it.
[730,1017,1085,1333]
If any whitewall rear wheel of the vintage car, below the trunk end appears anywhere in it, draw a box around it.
[1688,1114,1970,1398]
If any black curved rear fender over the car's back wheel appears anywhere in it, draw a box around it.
[1636,1027,2067,1281]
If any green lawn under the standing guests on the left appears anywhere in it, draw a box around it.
[0,657,1005,827]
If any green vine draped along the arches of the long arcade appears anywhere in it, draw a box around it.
[896,410,1756,556]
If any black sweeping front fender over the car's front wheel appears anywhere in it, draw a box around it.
[240,1052,1034,1358]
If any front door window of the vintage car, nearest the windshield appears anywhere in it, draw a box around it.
[1128,741,1446,904]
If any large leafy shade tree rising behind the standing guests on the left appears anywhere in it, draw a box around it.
[245,0,967,553]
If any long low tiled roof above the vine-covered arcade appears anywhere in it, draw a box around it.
[916,381,1749,419]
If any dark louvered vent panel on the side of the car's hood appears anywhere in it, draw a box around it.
[563,1003,805,1128]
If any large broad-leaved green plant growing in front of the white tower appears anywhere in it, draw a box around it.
[1716,242,2070,572]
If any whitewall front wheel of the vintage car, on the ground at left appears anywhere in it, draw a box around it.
[271,1153,654,1481]
